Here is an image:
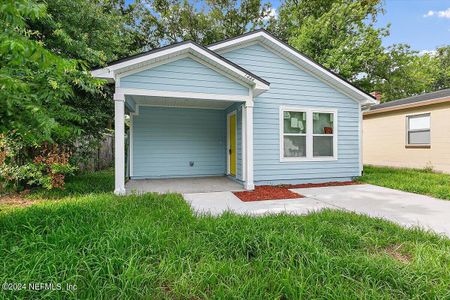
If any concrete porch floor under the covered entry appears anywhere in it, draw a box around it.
[125,176,244,194]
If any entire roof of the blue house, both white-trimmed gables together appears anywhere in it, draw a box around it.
[91,29,377,104]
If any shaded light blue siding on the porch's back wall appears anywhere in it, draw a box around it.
[132,106,226,178]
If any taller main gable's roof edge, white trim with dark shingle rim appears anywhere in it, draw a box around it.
[208,29,377,104]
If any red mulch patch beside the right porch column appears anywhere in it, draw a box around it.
[233,185,305,202]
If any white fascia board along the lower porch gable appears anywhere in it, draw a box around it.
[91,43,269,91]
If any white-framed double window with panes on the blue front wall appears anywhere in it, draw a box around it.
[280,107,337,161]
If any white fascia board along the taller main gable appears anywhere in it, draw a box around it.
[208,31,377,104]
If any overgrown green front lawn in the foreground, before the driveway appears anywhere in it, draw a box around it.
[0,171,450,299]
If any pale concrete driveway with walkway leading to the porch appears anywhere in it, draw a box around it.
[184,184,450,237]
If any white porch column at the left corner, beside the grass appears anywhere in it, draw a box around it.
[114,93,125,195]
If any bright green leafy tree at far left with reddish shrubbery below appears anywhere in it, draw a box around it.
[0,0,102,188]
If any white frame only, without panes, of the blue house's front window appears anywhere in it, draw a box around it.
[279,106,338,162]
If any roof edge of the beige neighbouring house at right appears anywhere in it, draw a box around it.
[369,89,450,112]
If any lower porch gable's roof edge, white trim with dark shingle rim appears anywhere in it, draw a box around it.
[91,41,270,94]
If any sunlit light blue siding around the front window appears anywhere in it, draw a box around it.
[222,44,359,184]
